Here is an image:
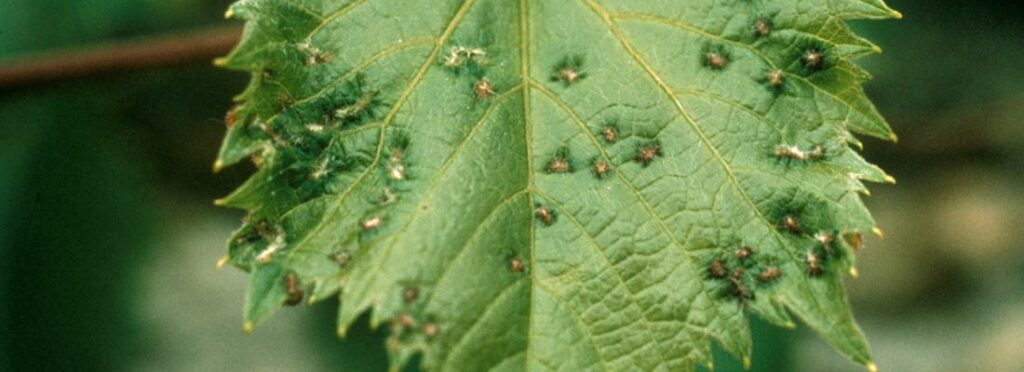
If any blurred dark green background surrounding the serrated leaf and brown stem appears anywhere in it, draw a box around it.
[0,0,1024,371]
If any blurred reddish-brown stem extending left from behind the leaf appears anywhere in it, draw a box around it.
[0,26,242,92]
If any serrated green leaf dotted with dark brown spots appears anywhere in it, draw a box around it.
[217,0,898,370]
